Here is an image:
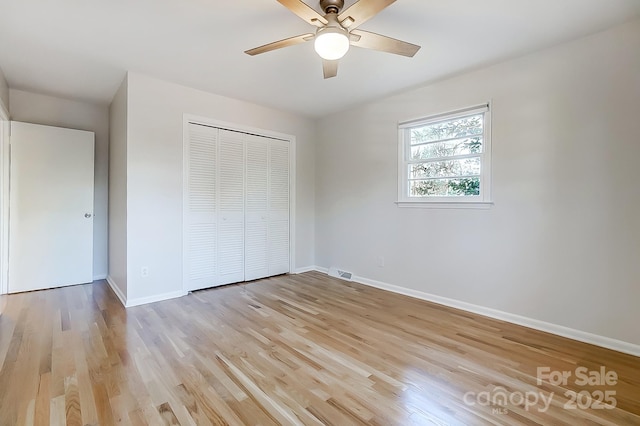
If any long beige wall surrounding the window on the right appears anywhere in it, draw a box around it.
[316,21,640,344]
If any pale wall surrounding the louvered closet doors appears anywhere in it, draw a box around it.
[127,73,315,302]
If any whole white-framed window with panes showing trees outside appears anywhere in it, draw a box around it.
[398,104,491,207]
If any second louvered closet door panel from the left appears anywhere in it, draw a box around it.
[218,130,245,285]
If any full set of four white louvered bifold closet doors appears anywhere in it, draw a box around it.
[183,122,290,291]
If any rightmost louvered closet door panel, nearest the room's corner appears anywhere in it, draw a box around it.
[268,140,289,275]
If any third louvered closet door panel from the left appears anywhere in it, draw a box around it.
[244,135,269,281]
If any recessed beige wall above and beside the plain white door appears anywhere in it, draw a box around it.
[9,89,109,279]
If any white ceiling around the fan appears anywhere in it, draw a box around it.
[0,0,640,117]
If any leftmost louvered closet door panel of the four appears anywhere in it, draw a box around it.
[184,123,218,291]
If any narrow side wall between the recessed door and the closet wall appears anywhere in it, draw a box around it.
[109,77,127,299]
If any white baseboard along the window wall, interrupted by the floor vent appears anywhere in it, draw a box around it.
[314,267,640,357]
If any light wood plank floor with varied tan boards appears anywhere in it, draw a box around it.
[0,273,640,426]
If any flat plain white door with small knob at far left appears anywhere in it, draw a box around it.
[9,122,95,293]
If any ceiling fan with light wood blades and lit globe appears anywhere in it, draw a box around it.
[245,0,420,78]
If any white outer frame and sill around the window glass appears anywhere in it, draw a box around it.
[396,102,493,208]
